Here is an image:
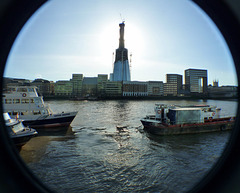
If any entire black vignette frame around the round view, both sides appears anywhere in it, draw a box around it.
[0,0,240,193]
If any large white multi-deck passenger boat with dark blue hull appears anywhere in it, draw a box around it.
[2,86,78,131]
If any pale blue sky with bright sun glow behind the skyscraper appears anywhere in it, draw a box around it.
[4,0,237,85]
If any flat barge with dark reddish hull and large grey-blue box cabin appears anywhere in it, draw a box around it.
[141,104,235,135]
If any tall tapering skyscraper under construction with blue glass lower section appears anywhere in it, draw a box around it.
[113,22,131,81]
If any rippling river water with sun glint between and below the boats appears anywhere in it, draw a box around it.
[20,100,237,193]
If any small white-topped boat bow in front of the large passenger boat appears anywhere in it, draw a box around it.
[3,113,38,149]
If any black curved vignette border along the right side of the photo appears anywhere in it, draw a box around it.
[190,0,240,193]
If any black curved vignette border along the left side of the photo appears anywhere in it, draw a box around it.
[0,0,51,193]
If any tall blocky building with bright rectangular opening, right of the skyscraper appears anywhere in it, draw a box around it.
[185,69,208,94]
